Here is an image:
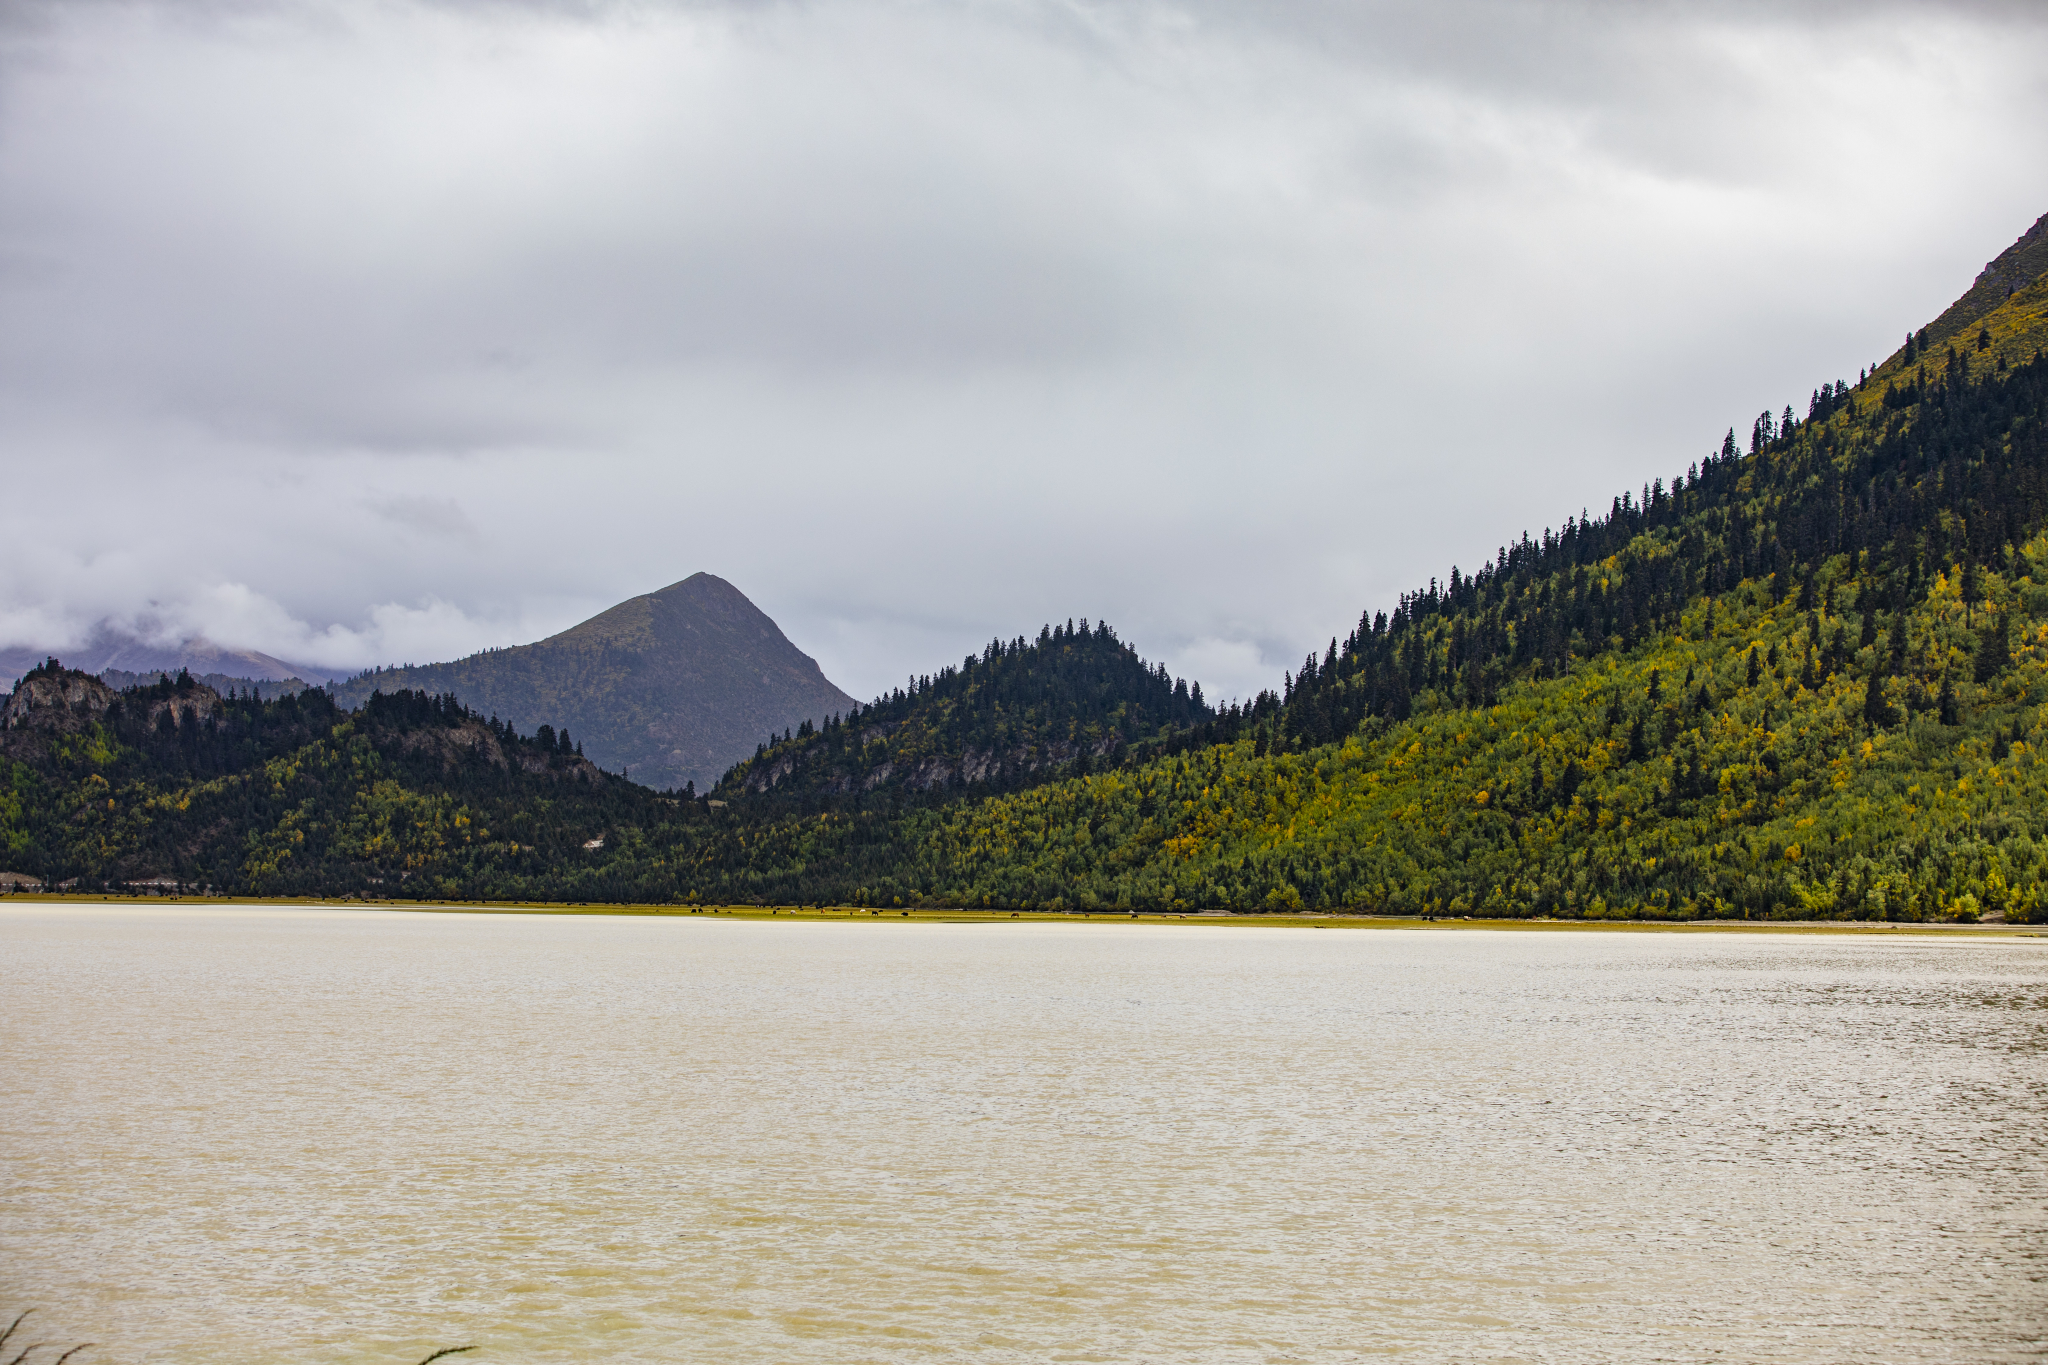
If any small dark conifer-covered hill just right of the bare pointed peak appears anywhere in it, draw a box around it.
[717,620,1212,800]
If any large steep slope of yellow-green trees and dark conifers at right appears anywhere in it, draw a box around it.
[557,215,2048,919]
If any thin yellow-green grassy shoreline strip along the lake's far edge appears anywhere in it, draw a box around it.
[0,892,2048,939]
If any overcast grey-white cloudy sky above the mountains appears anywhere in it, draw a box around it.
[0,0,2048,696]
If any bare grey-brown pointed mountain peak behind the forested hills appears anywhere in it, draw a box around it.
[332,573,854,788]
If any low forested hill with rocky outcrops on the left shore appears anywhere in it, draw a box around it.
[0,663,655,896]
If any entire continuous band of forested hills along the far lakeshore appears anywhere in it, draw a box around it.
[0,215,2048,921]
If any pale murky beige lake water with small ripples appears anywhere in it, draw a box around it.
[0,905,2048,1365]
